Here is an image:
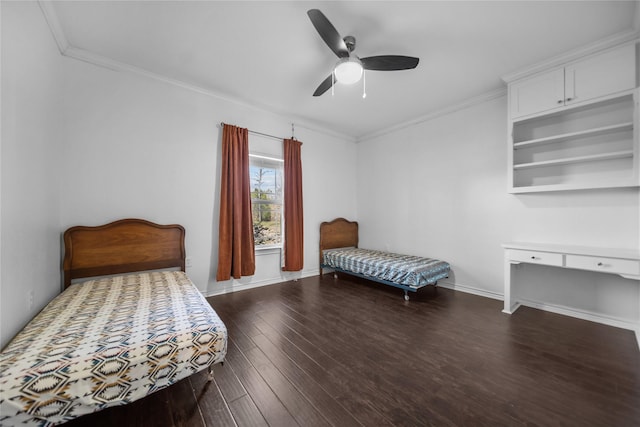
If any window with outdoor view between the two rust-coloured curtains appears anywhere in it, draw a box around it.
[249,153,284,247]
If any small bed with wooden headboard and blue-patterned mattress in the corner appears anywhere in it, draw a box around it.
[320,218,450,301]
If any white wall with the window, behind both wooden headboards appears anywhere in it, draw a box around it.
[61,60,356,295]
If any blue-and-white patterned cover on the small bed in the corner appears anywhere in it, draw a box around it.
[322,248,450,288]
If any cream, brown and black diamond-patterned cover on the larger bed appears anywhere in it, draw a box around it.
[0,271,227,426]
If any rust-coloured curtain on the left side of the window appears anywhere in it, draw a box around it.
[216,124,255,281]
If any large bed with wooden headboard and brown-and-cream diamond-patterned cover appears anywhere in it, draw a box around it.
[0,219,227,426]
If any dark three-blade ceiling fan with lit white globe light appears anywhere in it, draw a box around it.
[307,9,420,96]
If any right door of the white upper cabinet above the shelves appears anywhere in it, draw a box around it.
[565,45,636,105]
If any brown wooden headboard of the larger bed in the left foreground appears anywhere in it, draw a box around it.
[62,219,185,289]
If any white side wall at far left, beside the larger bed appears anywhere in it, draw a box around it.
[0,2,62,348]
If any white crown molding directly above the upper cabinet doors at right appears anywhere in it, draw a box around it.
[501,28,640,83]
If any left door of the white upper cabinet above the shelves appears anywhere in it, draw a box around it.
[509,68,565,118]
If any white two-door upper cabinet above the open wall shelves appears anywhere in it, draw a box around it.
[509,44,636,119]
